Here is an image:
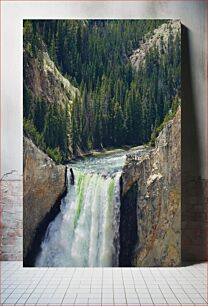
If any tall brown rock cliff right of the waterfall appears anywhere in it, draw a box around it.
[121,107,181,266]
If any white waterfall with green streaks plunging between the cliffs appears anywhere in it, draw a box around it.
[36,170,120,267]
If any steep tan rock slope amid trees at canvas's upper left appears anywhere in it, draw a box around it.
[23,50,79,107]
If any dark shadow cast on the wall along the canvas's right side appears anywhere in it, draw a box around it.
[181,25,208,264]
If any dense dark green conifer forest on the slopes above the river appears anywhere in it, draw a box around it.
[23,20,181,162]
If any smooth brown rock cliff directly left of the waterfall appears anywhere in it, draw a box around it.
[23,137,66,265]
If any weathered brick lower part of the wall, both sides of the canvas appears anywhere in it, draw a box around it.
[0,179,208,262]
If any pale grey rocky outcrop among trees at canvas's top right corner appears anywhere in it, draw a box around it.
[130,20,181,70]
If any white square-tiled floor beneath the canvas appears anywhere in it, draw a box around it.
[0,261,208,306]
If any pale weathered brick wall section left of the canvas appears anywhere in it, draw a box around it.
[0,180,23,260]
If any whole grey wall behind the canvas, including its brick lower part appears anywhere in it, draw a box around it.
[1,1,208,261]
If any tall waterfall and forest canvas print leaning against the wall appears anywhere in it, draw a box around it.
[23,19,181,267]
